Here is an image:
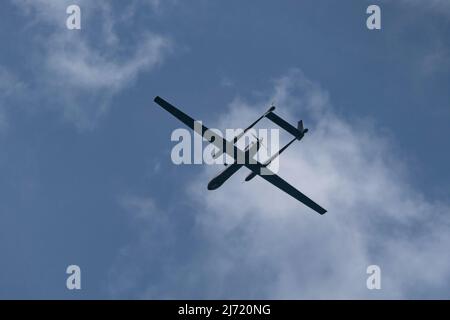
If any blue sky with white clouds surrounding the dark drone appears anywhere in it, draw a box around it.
[0,0,450,299]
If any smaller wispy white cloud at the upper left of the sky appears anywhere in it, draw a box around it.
[13,0,171,129]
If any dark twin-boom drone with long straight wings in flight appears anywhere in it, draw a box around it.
[154,97,327,214]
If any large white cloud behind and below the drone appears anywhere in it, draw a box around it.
[111,71,450,298]
